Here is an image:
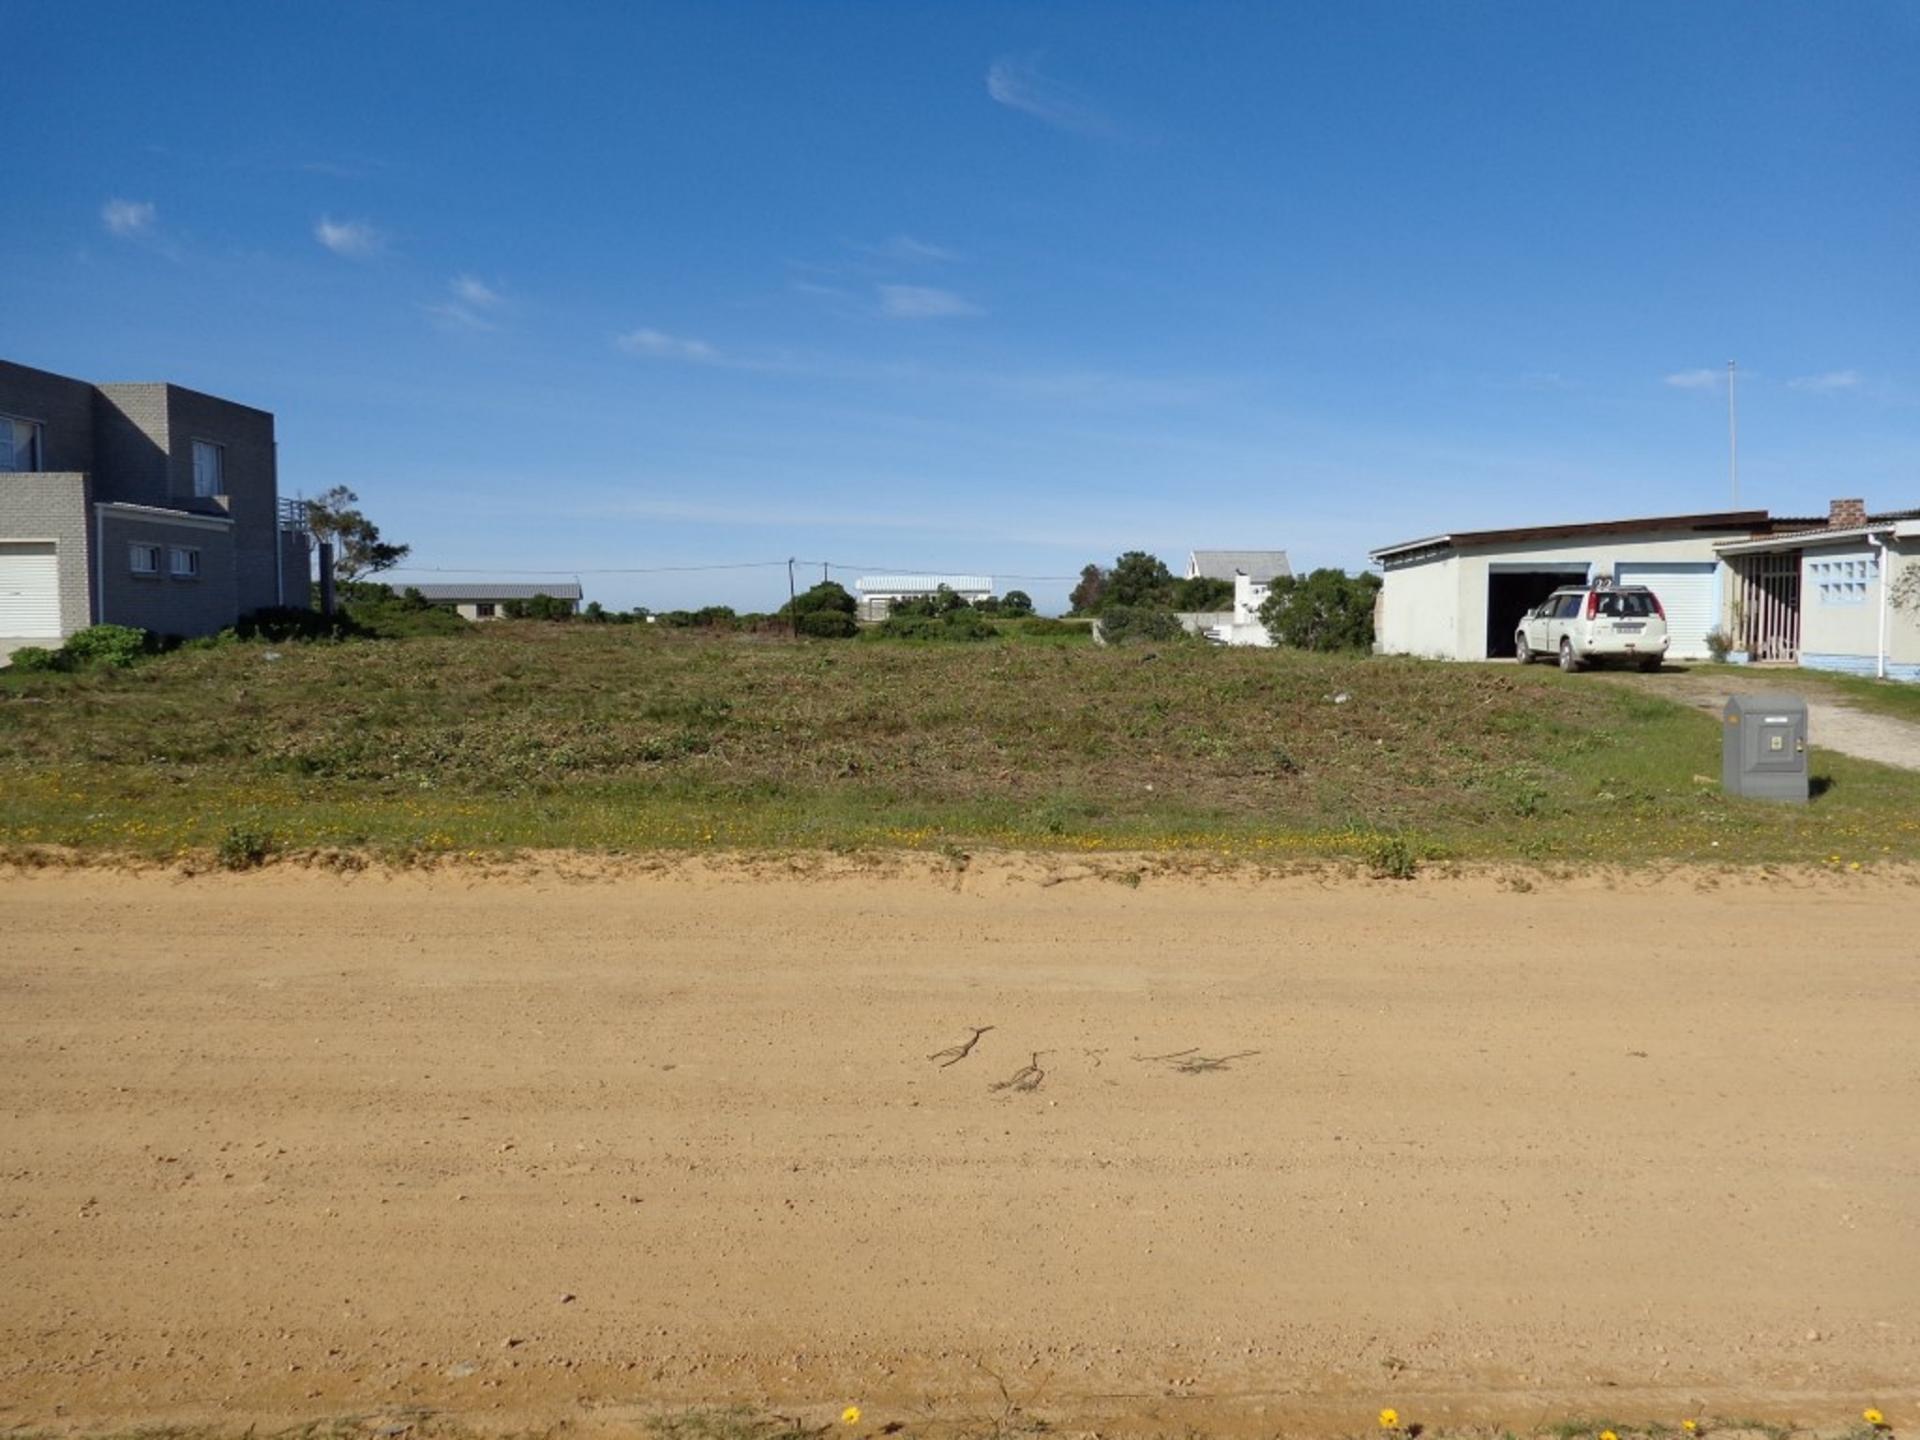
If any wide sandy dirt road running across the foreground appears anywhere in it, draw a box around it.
[0,860,1920,1434]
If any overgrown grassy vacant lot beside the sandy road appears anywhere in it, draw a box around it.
[0,624,1920,864]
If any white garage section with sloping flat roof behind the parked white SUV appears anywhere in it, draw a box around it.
[1373,511,1766,660]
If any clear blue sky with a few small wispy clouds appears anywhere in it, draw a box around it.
[0,0,1920,609]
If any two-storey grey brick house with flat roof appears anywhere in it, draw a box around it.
[0,361,307,647]
